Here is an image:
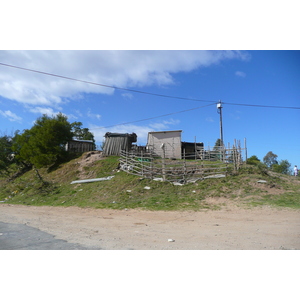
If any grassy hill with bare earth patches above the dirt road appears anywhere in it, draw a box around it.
[0,153,300,210]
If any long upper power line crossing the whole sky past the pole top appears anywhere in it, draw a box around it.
[0,62,300,109]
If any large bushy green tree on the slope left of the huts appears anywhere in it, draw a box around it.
[12,113,73,180]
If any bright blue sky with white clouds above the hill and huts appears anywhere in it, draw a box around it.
[0,50,300,169]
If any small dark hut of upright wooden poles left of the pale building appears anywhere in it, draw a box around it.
[103,132,137,156]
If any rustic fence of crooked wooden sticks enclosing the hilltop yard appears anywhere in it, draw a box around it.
[120,143,246,184]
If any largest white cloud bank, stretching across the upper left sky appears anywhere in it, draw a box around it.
[0,51,249,108]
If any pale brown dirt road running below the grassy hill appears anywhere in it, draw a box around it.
[0,204,300,250]
